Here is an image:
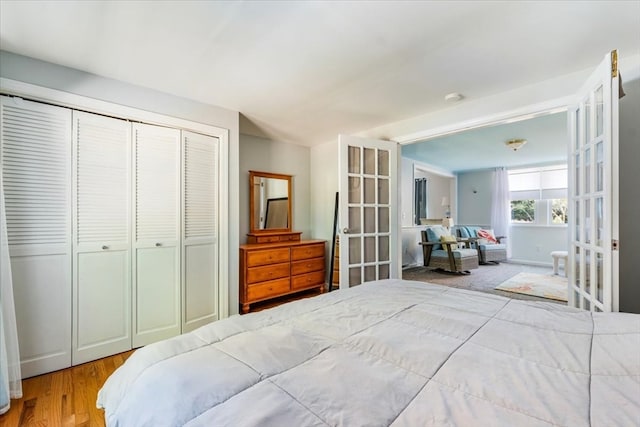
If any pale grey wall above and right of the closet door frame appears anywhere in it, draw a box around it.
[0,51,239,314]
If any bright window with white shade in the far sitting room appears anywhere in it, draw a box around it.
[509,165,568,225]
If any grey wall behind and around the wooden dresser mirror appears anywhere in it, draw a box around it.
[237,134,312,243]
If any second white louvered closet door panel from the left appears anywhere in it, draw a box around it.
[73,111,131,365]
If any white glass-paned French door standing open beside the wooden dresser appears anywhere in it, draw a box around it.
[338,135,400,289]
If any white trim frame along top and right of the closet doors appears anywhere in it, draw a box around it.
[0,77,230,319]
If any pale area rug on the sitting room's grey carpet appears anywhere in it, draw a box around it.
[495,273,567,301]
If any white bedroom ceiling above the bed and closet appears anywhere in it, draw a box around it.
[0,0,640,146]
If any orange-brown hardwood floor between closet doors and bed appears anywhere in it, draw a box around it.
[0,351,133,427]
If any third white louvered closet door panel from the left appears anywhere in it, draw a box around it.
[133,123,180,347]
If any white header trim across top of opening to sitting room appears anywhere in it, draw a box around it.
[393,96,574,145]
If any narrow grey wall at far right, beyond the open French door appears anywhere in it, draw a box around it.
[619,74,640,313]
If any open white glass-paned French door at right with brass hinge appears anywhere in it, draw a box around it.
[568,51,619,311]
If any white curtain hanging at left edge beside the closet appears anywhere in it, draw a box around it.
[0,185,22,414]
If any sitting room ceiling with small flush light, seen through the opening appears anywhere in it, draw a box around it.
[402,112,568,172]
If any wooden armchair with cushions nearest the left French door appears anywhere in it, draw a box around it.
[420,225,478,274]
